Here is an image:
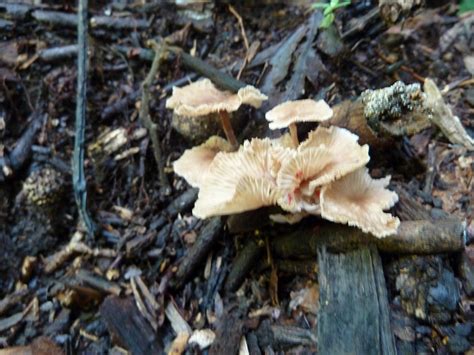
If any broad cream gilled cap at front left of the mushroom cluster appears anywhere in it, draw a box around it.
[193,139,277,218]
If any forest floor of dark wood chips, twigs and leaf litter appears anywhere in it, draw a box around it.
[0,1,474,354]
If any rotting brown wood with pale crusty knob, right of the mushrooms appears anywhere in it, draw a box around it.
[322,79,474,150]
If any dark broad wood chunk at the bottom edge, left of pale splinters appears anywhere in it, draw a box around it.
[100,296,164,355]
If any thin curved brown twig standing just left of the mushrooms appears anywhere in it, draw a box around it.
[140,41,170,191]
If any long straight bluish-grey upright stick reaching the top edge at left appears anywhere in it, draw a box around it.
[72,0,96,235]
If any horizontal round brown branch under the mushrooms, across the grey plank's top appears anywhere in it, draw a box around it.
[272,220,465,258]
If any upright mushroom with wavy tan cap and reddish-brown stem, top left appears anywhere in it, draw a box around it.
[166,79,267,148]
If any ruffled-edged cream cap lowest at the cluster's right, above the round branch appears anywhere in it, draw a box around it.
[320,168,400,238]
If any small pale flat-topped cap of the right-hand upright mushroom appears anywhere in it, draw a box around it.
[265,99,332,129]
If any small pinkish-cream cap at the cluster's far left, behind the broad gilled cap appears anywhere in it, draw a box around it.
[173,136,233,187]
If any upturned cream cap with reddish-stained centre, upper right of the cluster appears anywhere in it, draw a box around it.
[277,127,370,211]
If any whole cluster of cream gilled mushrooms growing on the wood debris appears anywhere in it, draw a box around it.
[167,80,400,238]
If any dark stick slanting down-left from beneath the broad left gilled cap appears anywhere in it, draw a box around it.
[174,217,223,287]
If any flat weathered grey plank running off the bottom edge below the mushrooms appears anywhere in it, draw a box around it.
[318,245,397,355]
